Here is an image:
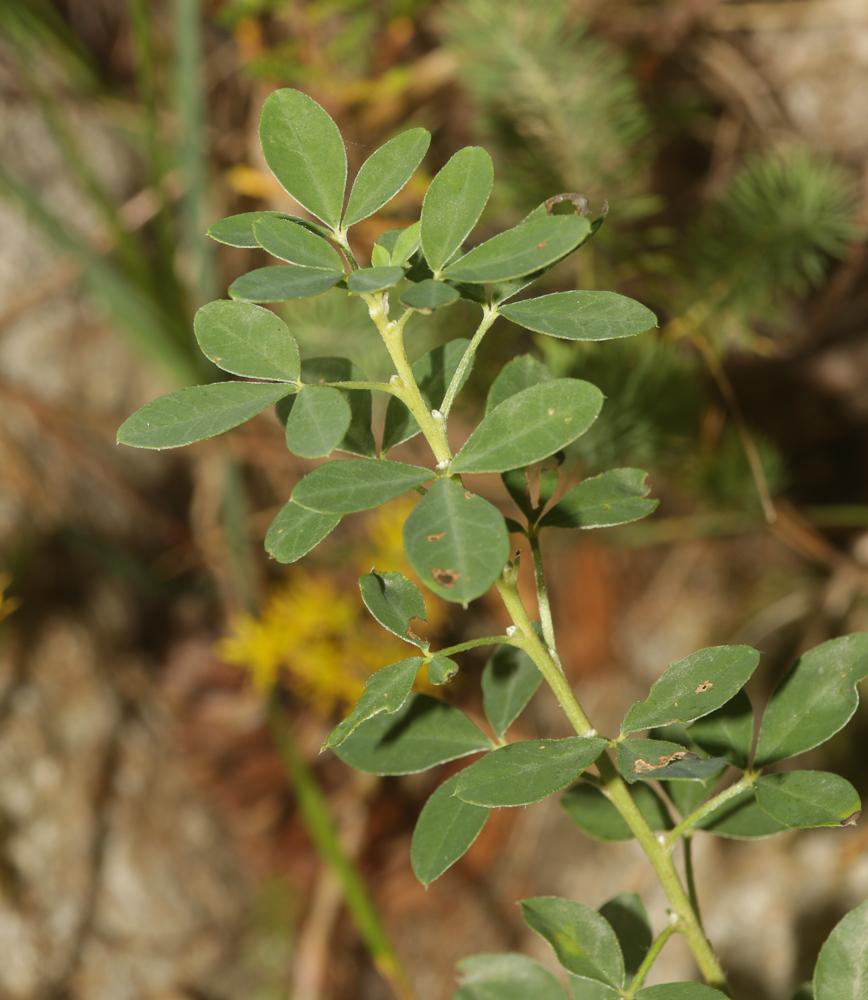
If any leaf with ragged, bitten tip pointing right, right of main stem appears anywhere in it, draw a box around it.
[540,469,660,528]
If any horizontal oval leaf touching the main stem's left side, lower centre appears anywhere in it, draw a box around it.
[455,736,606,808]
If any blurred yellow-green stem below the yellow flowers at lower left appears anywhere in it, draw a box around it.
[268,697,412,1000]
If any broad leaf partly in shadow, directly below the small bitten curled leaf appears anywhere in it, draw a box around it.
[336,694,491,775]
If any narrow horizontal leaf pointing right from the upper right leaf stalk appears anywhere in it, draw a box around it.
[500,292,657,340]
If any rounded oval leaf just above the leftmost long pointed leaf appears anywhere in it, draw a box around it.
[193,299,300,382]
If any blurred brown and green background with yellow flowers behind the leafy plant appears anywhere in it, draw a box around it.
[0,0,868,1000]
